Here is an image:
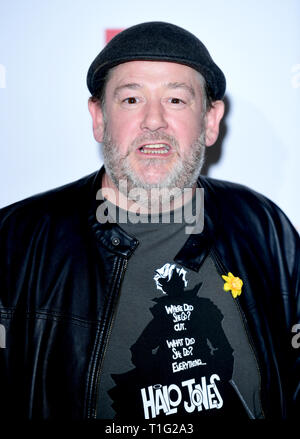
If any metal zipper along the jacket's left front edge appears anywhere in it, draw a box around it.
[90,258,128,419]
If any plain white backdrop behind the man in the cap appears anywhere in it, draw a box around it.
[0,0,300,229]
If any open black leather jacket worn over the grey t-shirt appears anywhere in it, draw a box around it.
[0,171,300,419]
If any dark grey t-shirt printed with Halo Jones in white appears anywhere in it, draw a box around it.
[97,208,263,420]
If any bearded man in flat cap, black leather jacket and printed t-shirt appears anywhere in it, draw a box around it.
[0,22,300,422]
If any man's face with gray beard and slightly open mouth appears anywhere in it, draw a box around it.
[89,61,223,189]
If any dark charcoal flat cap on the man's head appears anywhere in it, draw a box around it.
[87,21,226,100]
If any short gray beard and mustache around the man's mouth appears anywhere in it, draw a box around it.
[102,126,205,196]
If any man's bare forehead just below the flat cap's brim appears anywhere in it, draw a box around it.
[107,61,202,88]
